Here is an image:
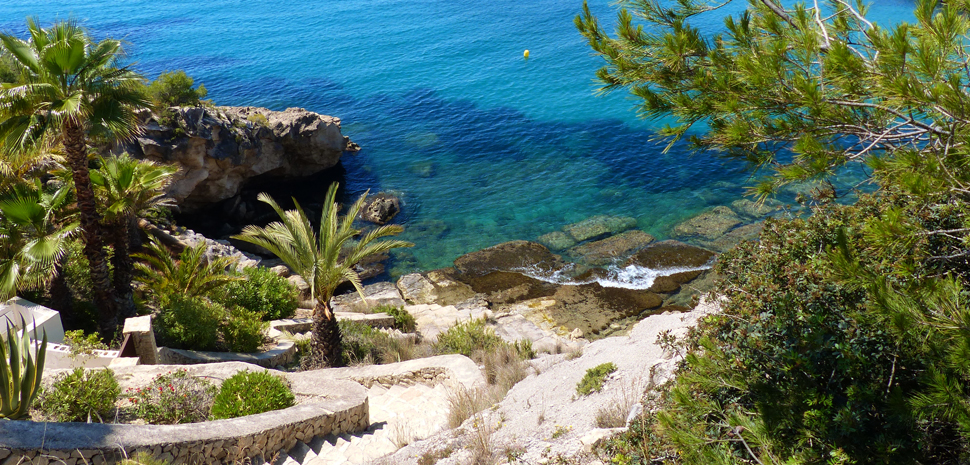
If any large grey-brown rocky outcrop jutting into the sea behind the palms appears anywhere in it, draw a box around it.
[110,107,358,212]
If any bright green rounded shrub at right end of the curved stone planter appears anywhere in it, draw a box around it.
[212,371,295,420]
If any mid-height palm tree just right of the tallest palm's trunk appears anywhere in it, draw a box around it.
[91,153,178,318]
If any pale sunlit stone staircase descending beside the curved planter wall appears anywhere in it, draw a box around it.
[274,368,449,465]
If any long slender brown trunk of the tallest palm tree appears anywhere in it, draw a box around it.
[63,119,118,340]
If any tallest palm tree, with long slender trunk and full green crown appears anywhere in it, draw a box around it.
[0,19,151,338]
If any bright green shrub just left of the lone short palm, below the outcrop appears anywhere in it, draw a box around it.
[218,266,300,321]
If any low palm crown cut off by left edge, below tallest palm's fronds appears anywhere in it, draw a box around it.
[0,181,78,302]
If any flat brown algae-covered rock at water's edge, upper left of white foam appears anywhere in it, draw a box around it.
[455,241,562,277]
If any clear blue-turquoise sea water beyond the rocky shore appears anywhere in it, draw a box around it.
[0,0,913,272]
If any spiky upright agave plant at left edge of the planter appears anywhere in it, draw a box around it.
[0,317,47,420]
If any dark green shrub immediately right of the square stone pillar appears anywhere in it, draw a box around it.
[155,295,228,350]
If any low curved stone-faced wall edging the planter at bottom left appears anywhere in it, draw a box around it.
[0,380,370,465]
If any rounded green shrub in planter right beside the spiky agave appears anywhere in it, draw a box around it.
[37,368,121,423]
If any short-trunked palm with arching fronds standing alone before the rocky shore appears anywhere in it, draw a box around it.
[235,183,414,366]
